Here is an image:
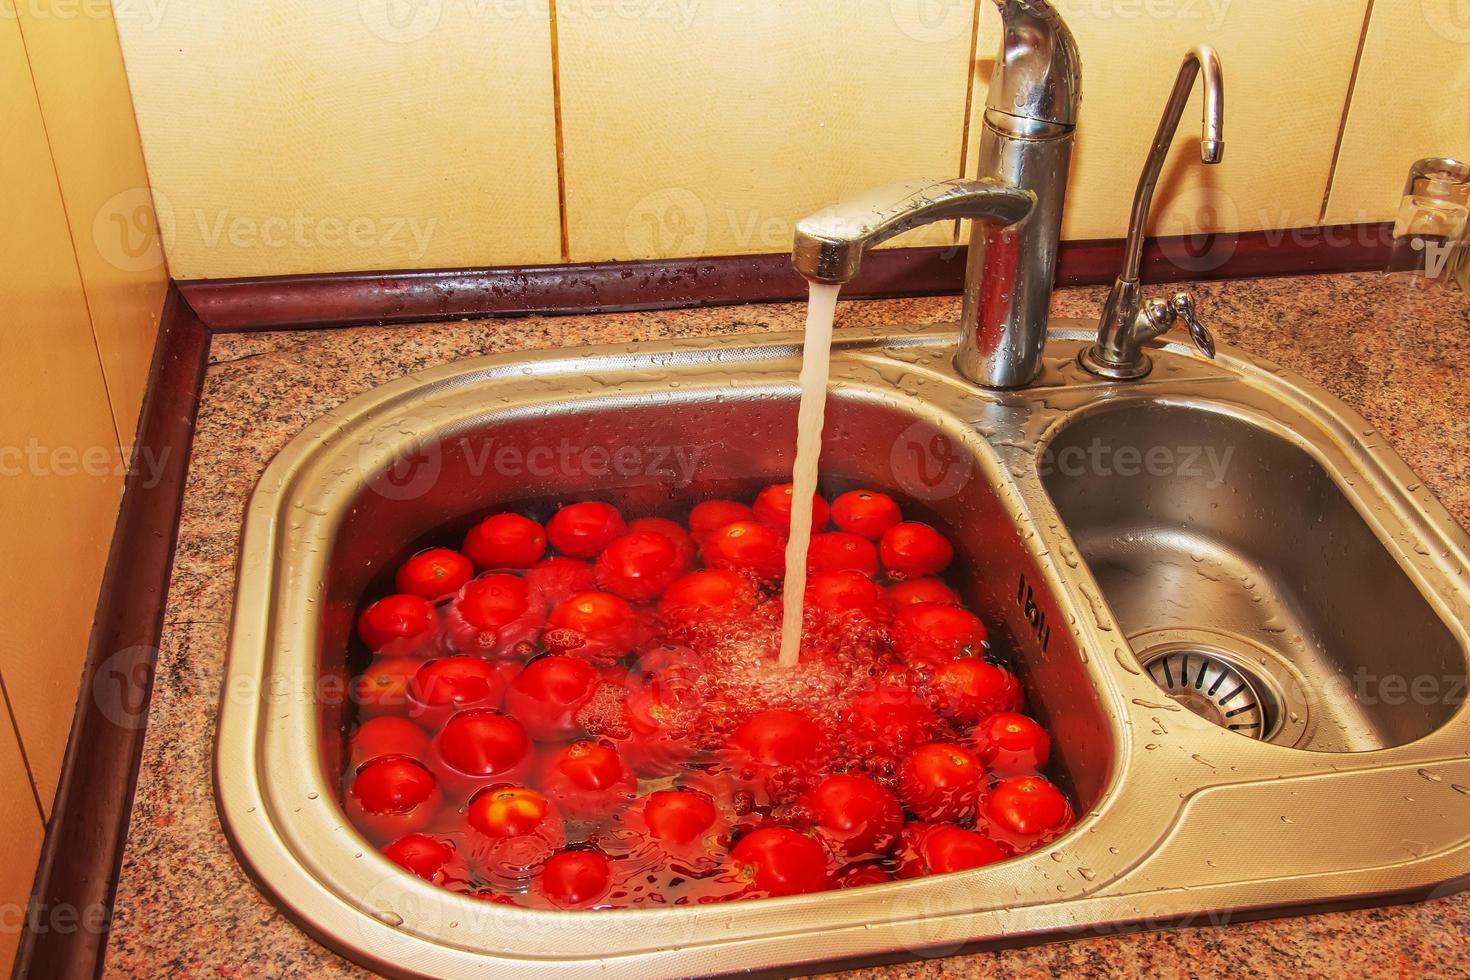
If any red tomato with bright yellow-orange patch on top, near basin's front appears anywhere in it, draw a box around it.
[465,786,566,886]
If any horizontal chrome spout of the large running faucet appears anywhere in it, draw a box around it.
[791,181,1036,285]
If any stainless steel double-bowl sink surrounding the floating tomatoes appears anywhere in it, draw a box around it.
[216,322,1470,977]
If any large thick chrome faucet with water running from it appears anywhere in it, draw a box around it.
[791,0,1082,388]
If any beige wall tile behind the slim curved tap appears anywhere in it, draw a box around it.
[972,0,1367,239]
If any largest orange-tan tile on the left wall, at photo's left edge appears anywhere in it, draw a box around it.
[0,18,122,805]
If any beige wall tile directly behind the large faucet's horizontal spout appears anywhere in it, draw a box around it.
[557,0,973,260]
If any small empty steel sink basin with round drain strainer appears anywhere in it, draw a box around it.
[1045,395,1466,752]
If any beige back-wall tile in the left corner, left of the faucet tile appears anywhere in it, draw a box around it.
[118,0,560,279]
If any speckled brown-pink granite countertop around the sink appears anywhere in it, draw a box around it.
[104,273,1470,977]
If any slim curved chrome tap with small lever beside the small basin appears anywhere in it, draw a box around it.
[1078,44,1225,381]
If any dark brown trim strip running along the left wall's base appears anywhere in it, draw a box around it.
[15,285,209,980]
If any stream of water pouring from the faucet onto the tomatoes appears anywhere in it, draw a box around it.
[779,282,842,667]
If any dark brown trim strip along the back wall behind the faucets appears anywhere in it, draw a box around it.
[179,225,1391,332]
